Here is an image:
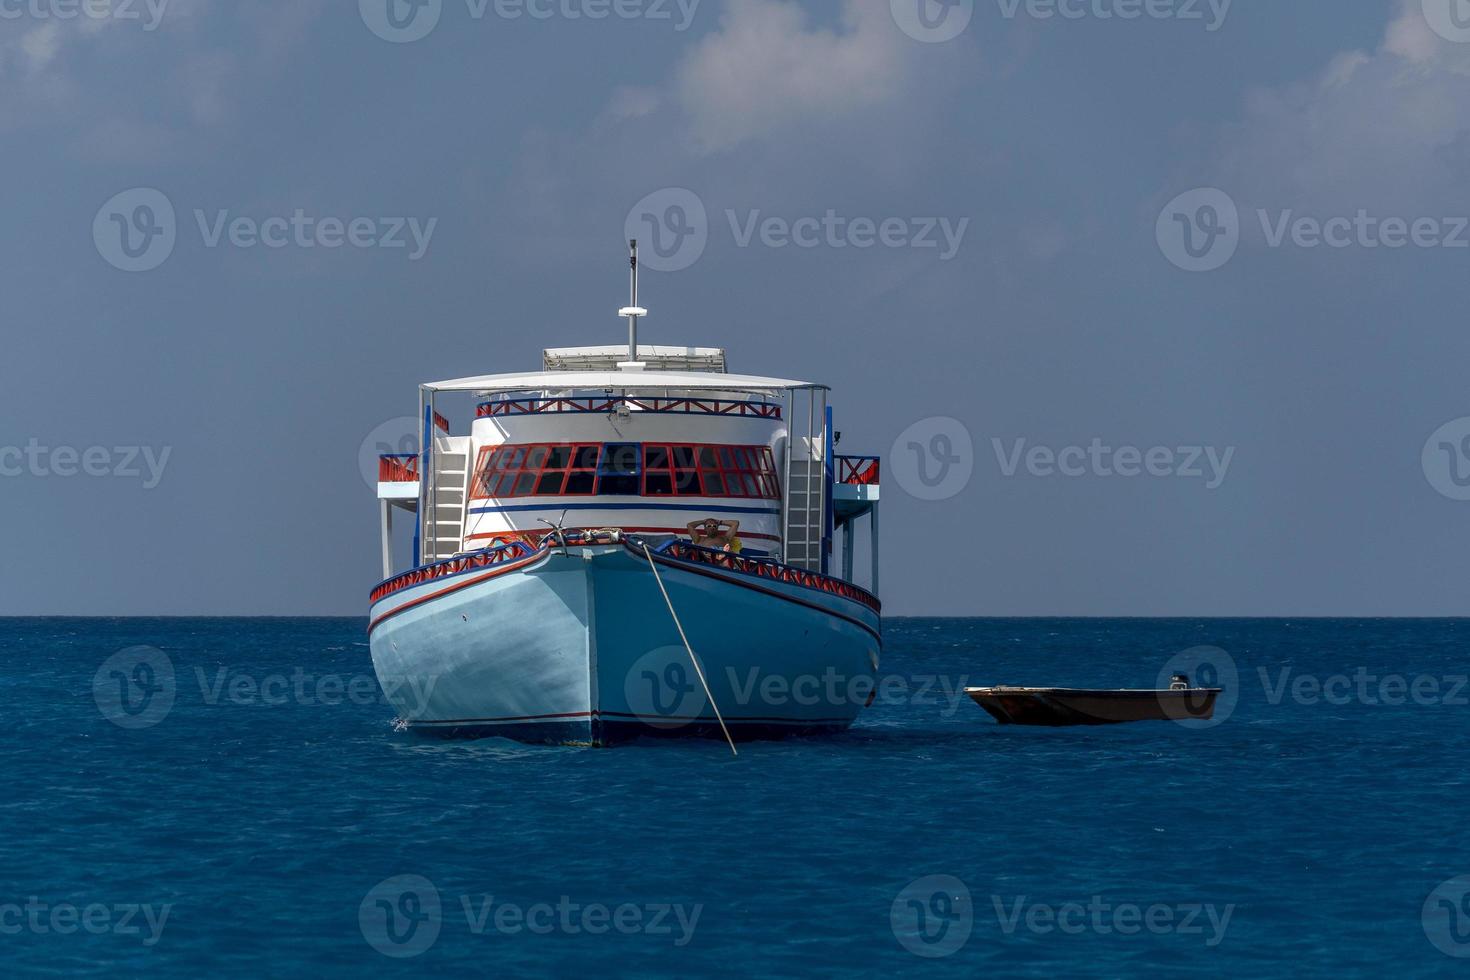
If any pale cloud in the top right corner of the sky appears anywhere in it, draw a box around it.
[1204,0,1470,216]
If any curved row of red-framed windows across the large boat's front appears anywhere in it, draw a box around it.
[470,442,781,500]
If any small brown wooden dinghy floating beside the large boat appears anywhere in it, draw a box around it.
[964,674,1222,727]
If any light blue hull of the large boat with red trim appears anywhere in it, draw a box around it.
[370,545,882,745]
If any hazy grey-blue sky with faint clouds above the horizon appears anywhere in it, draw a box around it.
[0,0,1470,616]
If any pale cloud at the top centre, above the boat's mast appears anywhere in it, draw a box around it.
[675,0,919,151]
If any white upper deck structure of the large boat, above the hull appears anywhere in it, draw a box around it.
[379,345,878,590]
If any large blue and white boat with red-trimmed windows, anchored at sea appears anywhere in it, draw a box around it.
[368,241,882,749]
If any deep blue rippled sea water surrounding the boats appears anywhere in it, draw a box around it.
[0,620,1470,977]
